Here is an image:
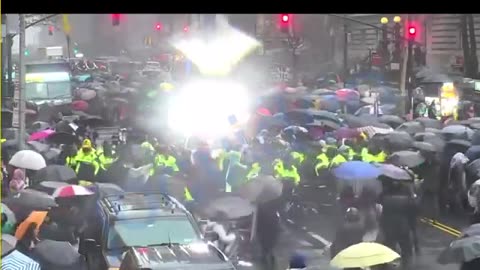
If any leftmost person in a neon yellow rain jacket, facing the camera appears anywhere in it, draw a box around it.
[75,139,100,181]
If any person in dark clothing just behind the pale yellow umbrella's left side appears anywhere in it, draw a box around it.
[330,207,365,259]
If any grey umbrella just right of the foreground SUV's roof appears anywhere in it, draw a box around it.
[201,196,255,220]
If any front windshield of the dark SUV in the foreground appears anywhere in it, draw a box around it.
[107,217,200,249]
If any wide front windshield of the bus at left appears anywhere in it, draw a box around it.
[25,82,71,100]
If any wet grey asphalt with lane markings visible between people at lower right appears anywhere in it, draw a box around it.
[240,185,468,270]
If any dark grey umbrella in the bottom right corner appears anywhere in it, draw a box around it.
[437,235,480,264]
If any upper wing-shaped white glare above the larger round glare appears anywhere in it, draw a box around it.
[172,25,260,75]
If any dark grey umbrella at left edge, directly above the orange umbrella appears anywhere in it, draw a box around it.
[2,189,57,220]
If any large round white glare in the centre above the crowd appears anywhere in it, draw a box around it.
[168,81,250,138]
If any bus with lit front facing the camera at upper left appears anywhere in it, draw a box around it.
[25,60,73,105]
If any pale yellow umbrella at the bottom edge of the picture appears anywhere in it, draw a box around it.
[330,242,400,268]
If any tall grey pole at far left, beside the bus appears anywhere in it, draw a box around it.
[17,14,26,150]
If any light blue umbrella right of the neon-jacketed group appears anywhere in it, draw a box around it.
[333,161,382,181]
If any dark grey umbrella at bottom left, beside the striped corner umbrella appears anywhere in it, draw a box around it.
[33,239,81,266]
